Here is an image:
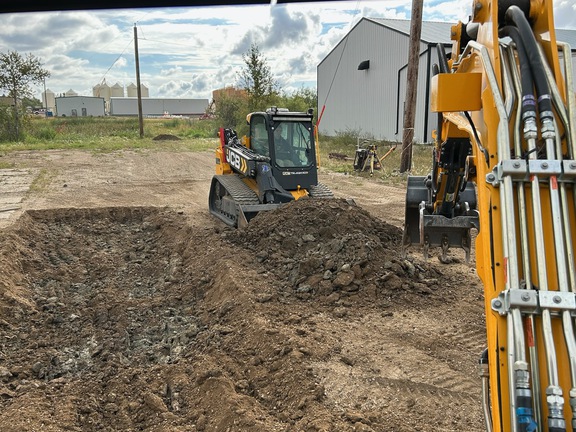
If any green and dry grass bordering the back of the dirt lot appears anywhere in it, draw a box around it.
[5,117,432,187]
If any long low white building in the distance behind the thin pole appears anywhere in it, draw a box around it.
[110,97,208,116]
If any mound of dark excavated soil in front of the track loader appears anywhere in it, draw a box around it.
[228,199,438,301]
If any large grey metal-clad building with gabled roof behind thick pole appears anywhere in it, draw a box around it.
[317,18,576,143]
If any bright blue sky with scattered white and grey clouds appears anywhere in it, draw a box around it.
[0,0,576,99]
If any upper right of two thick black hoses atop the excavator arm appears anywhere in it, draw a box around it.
[505,6,553,121]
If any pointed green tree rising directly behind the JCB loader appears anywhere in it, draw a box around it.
[239,44,278,111]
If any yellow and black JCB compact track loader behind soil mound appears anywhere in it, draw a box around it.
[208,107,333,227]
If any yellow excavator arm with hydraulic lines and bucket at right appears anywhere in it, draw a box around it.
[404,0,576,432]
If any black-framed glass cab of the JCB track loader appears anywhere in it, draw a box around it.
[247,107,318,191]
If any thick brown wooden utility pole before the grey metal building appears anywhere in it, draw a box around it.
[400,0,423,173]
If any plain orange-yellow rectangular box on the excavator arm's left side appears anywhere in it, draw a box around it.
[430,72,482,112]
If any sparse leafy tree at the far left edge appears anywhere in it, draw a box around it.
[0,51,50,140]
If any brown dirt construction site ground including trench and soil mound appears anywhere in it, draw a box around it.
[0,151,485,432]
